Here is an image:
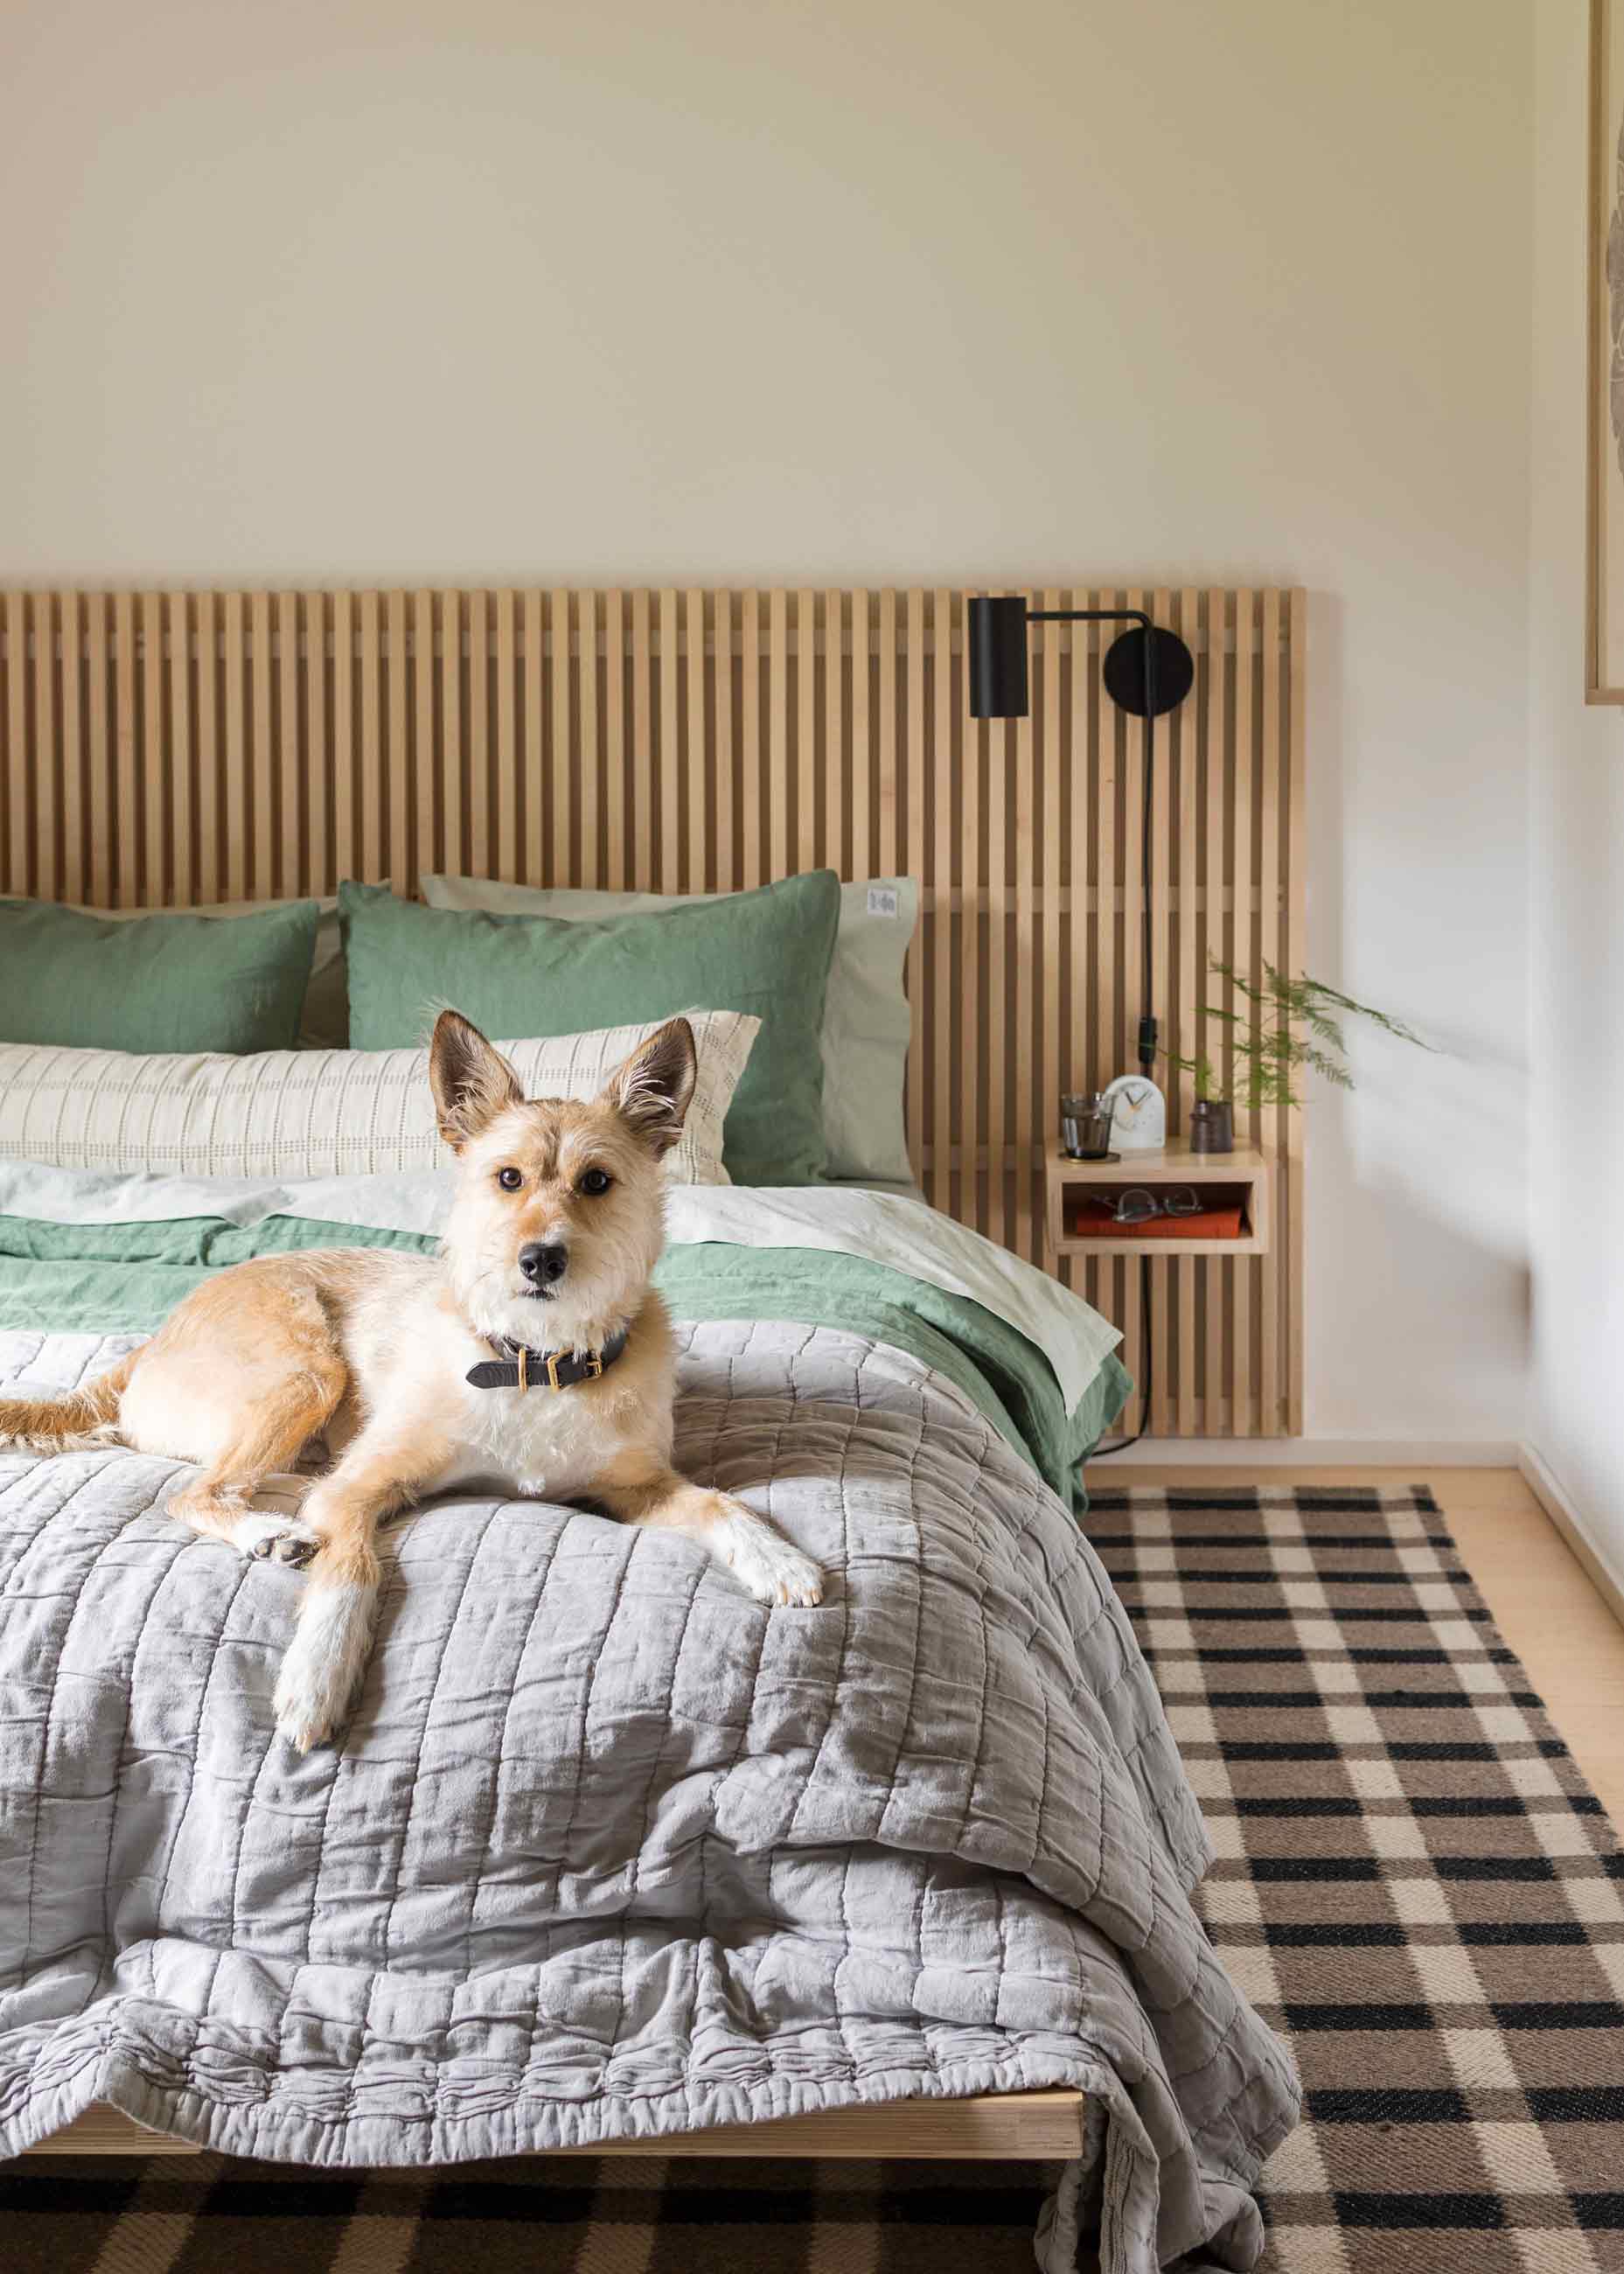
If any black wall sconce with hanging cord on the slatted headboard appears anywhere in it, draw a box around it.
[969,594,1196,1078]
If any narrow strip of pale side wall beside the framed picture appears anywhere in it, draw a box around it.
[1529,0,1624,1545]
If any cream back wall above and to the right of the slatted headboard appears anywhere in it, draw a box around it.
[0,0,1533,1441]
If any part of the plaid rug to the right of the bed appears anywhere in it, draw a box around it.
[1087,1487,1624,2274]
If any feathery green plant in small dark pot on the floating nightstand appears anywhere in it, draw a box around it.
[1165,955,1431,1153]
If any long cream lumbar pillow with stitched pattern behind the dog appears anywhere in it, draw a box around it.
[0,1009,762,1185]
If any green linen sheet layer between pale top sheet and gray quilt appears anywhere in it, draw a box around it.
[0,1214,1133,1510]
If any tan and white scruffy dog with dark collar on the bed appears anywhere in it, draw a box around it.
[0,1009,824,1754]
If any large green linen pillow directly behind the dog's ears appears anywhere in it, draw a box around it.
[339,868,840,1185]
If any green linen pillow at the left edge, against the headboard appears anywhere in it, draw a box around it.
[0,901,321,1055]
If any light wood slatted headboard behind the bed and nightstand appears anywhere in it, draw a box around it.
[0,589,1303,1437]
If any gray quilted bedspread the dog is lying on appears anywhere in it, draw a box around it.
[0,1323,1296,2274]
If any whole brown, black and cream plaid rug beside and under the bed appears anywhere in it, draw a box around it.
[0,1487,1624,2274]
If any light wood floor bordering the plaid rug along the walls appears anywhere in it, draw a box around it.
[1114,1464,1624,1828]
